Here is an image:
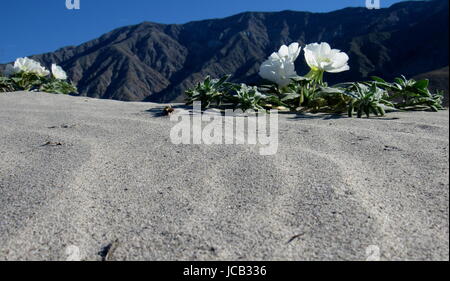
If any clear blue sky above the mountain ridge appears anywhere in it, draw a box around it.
[0,0,401,63]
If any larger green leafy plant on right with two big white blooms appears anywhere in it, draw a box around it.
[186,43,443,117]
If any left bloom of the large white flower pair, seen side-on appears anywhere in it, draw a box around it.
[259,43,301,87]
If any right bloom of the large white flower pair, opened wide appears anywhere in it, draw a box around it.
[305,43,350,73]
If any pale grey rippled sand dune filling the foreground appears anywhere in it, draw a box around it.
[0,93,449,260]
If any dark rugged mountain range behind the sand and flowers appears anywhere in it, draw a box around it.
[0,0,449,102]
